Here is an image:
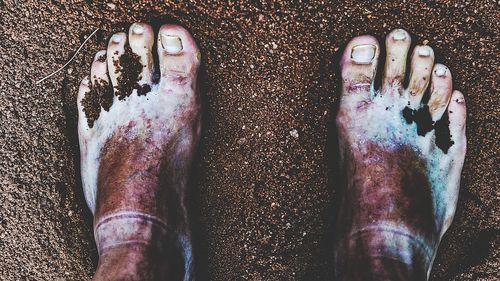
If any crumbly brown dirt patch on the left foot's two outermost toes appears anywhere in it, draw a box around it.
[81,78,113,128]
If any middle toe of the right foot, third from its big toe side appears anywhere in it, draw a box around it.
[406,46,434,109]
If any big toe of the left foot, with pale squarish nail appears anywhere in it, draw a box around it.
[158,24,201,86]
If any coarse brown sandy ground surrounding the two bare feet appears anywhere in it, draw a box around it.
[0,0,500,280]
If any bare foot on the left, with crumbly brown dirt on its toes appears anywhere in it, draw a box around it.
[78,24,200,280]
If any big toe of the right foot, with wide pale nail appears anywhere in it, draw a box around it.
[340,35,380,96]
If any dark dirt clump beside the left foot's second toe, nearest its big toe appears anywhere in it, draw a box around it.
[113,44,151,100]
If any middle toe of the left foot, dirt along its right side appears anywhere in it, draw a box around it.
[107,32,127,92]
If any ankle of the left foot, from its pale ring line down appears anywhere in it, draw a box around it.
[94,210,168,280]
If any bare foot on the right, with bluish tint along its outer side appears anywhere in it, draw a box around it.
[336,29,466,280]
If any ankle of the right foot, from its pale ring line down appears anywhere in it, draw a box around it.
[335,222,436,280]
